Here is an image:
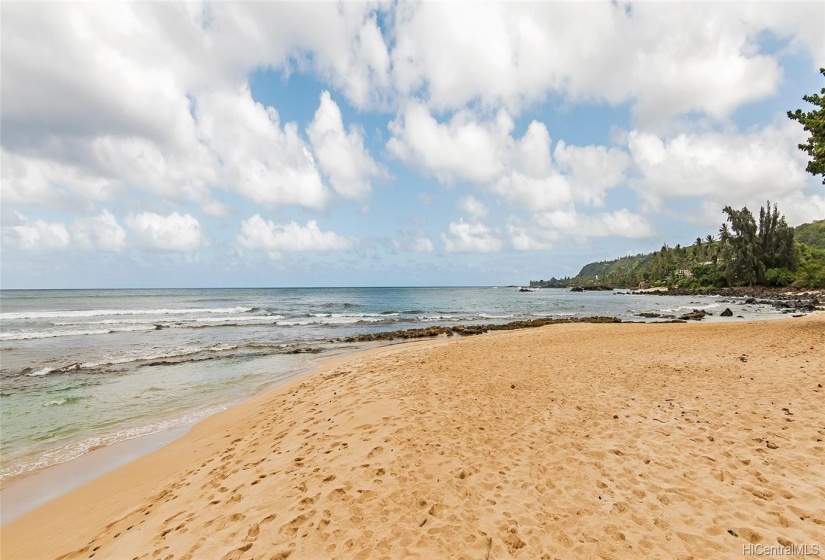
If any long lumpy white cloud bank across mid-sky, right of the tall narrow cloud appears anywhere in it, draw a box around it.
[387,104,630,215]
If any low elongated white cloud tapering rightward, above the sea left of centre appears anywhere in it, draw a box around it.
[237,214,355,259]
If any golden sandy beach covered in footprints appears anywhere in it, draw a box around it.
[0,313,825,559]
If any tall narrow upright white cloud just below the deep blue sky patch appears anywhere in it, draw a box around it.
[307,91,382,199]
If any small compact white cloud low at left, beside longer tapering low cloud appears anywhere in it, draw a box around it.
[126,212,203,253]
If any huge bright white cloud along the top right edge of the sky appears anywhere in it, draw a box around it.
[391,2,825,122]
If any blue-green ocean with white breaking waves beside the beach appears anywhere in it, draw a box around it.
[0,287,781,480]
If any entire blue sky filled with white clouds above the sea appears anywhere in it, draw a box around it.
[0,1,825,289]
